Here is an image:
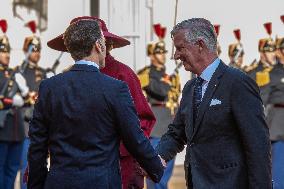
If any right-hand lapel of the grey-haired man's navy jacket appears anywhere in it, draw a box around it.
[191,61,227,139]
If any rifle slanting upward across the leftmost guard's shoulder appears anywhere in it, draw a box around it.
[0,45,33,98]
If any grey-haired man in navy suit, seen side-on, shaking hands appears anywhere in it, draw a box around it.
[157,18,272,189]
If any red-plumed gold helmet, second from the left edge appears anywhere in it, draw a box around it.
[23,21,41,52]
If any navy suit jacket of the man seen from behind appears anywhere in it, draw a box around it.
[28,65,163,189]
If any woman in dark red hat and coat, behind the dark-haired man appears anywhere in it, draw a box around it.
[47,16,156,189]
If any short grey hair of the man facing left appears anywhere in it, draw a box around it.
[171,18,217,52]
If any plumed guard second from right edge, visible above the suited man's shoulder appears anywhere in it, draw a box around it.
[244,22,276,88]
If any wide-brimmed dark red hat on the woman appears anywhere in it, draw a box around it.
[47,16,130,52]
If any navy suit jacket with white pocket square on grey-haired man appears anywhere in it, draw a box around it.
[157,62,271,189]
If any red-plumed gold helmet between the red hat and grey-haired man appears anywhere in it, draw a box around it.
[147,24,168,56]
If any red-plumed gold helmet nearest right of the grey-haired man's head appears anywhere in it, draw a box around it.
[228,29,244,58]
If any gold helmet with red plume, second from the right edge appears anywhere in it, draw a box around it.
[258,22,276,52]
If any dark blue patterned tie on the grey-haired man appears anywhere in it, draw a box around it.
[193,77,204,125]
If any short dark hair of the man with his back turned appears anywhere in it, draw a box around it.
[63,19,102,61]
